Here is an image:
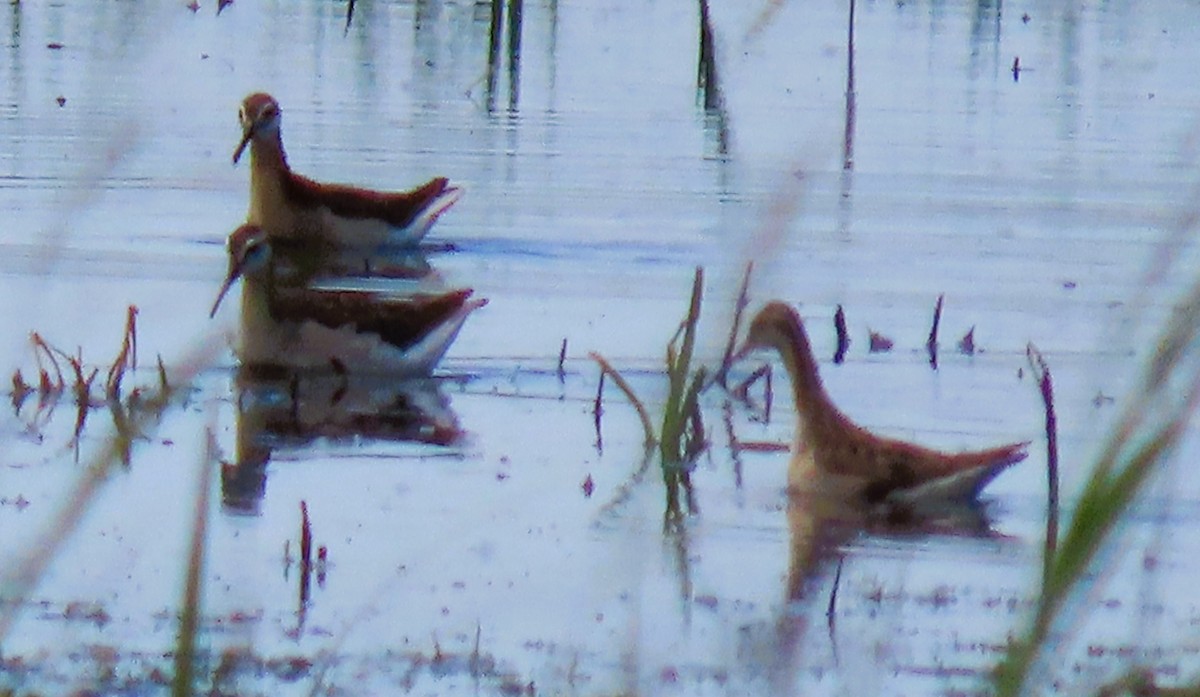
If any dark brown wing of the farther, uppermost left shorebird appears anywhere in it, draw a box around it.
[284,174,450,228]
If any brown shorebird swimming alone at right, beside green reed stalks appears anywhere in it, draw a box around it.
[739,302,1028,506]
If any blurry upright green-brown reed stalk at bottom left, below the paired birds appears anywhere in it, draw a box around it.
[170,428,217,697]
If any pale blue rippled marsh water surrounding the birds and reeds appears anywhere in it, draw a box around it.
[0,0,1200,695]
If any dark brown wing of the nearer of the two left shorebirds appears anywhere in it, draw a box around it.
[271,288,473,349]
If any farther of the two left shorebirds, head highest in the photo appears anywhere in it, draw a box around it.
[233,92,462,253]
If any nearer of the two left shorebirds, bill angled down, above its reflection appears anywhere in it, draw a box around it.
[209,224,487,375]
